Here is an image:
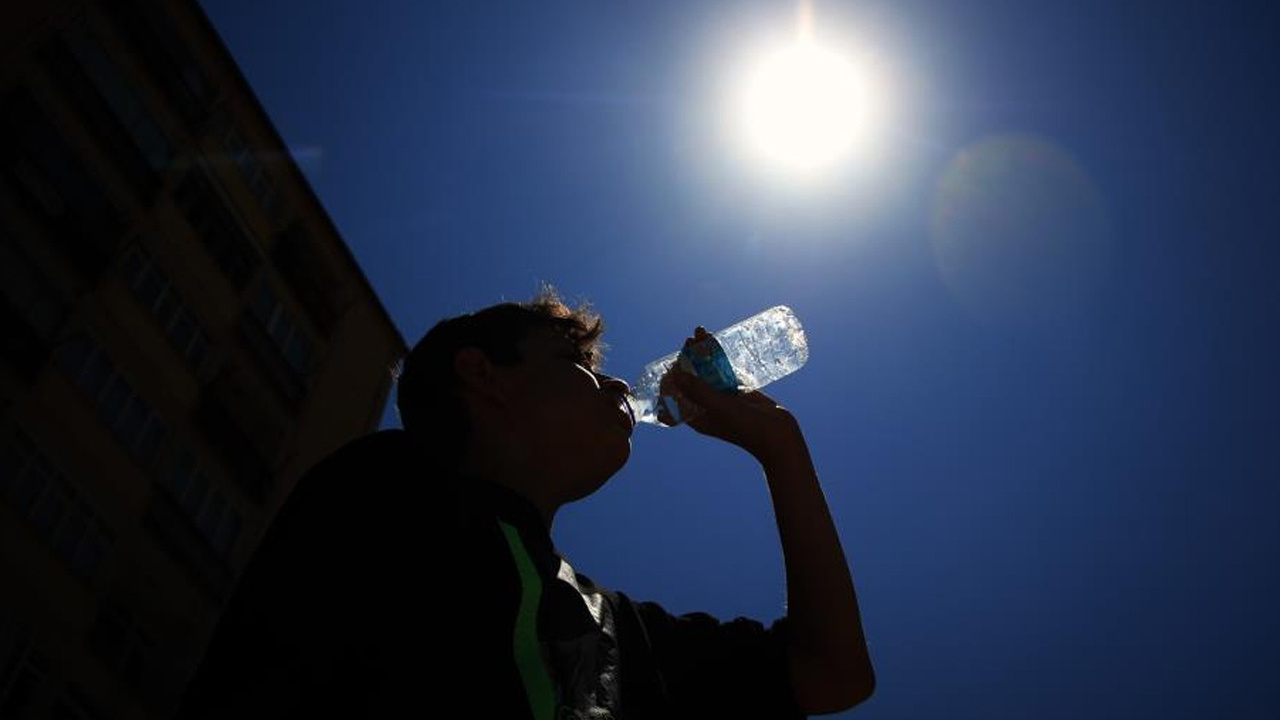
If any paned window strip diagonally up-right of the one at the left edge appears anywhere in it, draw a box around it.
[55,334,168,470]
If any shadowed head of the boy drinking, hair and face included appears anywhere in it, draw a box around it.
[397,287,630,515]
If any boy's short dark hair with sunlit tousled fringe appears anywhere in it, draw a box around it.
[396,284,605,470]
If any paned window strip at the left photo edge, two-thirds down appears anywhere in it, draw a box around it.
[0,434,111,579]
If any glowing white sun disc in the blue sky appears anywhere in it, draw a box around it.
[742,37,868,172]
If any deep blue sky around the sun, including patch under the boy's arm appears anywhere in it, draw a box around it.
[194,0,1280,720]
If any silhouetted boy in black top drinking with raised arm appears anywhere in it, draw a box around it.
[179,288,874,720]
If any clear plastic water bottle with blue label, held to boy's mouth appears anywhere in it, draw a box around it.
[628,305,809,427]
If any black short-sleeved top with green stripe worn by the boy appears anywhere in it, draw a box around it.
[178,430,804,720]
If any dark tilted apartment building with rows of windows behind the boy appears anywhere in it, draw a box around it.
[0,0,404,720]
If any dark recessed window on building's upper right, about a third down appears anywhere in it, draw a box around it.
[175,170,262,291]
